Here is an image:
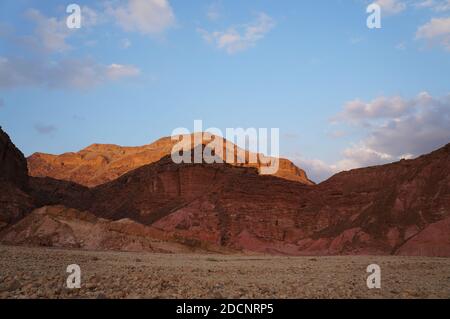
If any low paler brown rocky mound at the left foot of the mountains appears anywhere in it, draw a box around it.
[1,206,209,253]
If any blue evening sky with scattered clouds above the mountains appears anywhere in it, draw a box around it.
[0,0,450,182]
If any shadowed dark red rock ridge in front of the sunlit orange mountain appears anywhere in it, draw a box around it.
[0,127,450,256]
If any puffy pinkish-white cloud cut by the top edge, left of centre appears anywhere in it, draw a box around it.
[108,0,175,34]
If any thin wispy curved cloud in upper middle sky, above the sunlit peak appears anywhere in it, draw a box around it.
[198,13,275,54]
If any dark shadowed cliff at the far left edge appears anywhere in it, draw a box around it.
[0,128,33,230]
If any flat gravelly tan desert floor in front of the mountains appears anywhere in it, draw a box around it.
[0,246,450,298]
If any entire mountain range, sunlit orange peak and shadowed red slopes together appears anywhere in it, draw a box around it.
[0,127,450,256]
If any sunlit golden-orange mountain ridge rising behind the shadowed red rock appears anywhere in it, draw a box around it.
[28,133,314,187]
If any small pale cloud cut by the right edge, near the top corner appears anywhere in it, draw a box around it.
[416,17,450,51]
